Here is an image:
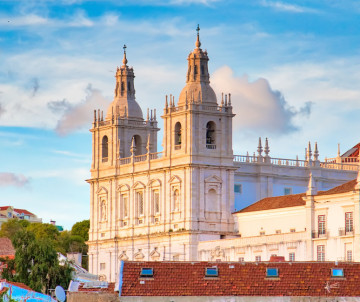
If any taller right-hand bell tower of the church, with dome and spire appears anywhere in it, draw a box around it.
[163,26,234,165]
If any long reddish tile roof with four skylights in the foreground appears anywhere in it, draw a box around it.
[116,261,360,297]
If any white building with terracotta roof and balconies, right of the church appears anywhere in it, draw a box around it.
[199,173,360,262]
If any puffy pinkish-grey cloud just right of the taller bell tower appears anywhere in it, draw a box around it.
[212,66,311,134]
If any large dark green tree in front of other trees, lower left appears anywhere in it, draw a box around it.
[4,230,72,293]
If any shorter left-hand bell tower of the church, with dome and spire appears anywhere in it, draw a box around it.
[90,45,159,169]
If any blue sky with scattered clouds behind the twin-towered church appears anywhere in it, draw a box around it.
[0,0,360,228]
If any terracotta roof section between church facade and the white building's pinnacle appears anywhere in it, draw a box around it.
[235,193,305,213]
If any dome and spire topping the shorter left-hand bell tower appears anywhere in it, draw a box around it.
[106,45,143,120]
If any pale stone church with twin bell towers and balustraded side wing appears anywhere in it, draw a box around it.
[87,27,358,281]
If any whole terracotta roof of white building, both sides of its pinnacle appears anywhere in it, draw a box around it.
[234,179,356,213]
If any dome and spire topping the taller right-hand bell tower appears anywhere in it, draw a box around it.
[178,25,217,106]
